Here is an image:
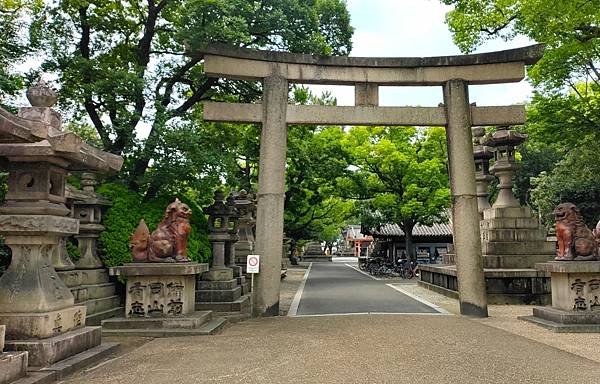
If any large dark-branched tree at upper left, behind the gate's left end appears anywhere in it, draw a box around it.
[42,0,352,198]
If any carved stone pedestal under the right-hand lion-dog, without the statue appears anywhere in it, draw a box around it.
[522,261,600,332]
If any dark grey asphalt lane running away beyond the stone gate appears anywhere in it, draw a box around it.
[296,263,439,316]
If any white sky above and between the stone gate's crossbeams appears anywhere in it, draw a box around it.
[311,0,534,106]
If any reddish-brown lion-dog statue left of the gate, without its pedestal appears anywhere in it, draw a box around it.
[129,199,192,263]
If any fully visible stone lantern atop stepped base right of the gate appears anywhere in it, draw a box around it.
[484,126,527,208]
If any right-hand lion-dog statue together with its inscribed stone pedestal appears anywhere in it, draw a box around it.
[522,203,600,332]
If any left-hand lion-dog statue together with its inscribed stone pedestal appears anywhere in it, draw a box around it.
[102,199,223,337]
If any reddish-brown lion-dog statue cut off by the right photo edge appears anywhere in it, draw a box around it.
[554,203,600,261]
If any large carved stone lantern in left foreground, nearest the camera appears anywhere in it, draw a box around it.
[0,82,123,366]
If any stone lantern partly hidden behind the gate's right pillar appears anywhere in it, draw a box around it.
[472,127,494,215]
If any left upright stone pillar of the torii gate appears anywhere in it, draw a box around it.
[252,75,288,316]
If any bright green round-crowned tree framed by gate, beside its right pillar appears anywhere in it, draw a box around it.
[340,127,450,260]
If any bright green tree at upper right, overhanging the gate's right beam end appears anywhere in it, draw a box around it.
[442,0,600,223]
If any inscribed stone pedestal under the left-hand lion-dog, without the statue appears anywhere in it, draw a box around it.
[102,263,226,337]
